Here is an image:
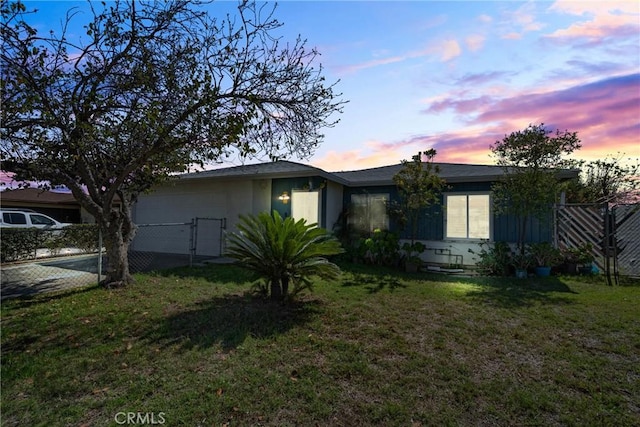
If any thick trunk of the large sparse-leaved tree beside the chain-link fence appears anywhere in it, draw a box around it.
[100,212,135,287]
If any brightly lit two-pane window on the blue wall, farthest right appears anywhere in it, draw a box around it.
[445,194,491,239]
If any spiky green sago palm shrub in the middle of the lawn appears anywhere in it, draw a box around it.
[226,211,343,301]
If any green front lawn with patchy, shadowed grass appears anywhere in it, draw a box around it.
[1,265,640,426]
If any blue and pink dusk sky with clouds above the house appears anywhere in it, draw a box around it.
[5,1,640,177]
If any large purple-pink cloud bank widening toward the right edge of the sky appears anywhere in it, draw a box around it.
[424,74,640,162]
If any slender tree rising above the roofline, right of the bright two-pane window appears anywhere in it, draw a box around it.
[491,123,581,253]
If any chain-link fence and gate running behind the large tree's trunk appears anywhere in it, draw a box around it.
[0,218,226,300]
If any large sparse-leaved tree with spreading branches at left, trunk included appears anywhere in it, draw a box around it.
[0,0,344,286]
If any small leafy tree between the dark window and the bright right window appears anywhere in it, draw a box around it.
[389,149,446,243]
